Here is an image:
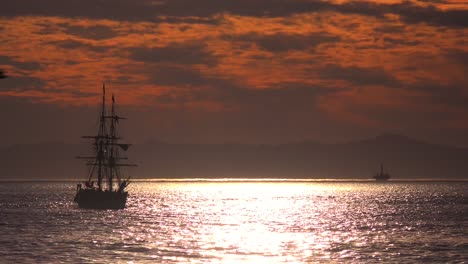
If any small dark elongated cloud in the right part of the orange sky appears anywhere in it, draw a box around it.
[320,65,401,87]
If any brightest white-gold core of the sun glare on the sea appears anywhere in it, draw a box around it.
[129,182,362,263]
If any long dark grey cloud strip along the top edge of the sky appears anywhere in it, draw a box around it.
[0,0,329,21]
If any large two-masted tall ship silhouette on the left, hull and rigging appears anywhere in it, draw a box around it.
[74,84,136,209]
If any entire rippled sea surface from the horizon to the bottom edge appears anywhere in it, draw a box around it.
[0,180,468,263]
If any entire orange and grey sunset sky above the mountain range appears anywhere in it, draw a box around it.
[0,0,468,147]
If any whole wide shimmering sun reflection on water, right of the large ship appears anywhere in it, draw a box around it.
[112,181,466,263]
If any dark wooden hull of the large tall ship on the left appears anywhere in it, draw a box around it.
[75,189,128,209]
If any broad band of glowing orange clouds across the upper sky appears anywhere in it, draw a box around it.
[0,1,468,134]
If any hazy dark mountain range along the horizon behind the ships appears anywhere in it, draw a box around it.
[0,134,468,180]
